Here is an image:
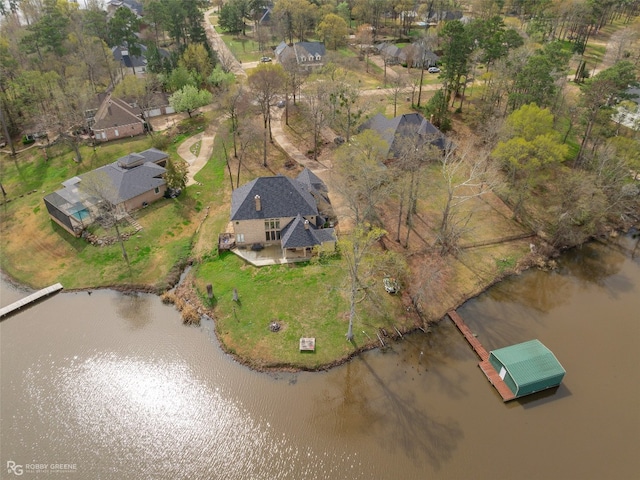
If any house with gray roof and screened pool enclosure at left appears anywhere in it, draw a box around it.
[43,148,169,237]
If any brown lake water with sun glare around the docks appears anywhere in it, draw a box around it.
[0,234,640,480]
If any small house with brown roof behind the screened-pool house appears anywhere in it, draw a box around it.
[91,94,145,142]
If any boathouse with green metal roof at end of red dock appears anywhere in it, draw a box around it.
[489,340,566,398]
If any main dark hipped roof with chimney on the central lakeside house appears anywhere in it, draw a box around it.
[231,175,318,220]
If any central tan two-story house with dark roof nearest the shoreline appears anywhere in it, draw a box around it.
[231,169,336,258]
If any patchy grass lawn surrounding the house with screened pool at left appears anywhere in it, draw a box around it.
[0,119,218,289]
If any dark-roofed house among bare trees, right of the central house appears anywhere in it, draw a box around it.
[359,113,446,158]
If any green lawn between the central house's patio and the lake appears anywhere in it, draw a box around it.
[196,252,411,369]
